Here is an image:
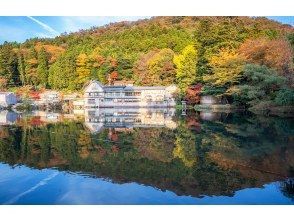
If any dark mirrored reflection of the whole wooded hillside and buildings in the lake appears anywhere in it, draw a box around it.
[0,109,294,204]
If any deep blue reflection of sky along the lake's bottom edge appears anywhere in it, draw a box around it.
[0,164,293,204]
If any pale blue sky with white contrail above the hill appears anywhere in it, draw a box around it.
[0,16,294,44]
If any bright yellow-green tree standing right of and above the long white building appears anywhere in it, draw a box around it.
[173,45,197,92]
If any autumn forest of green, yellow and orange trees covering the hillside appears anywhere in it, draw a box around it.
[0,17,294,110]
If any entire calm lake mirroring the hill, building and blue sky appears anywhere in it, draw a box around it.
[0,109,294,204]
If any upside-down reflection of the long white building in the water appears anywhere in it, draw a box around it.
[85,108,177,132]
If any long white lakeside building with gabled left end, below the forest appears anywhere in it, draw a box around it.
[84,80,177,108]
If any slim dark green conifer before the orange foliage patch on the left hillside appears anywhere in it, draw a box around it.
[37,47,48,87]
